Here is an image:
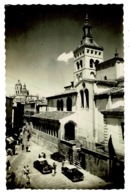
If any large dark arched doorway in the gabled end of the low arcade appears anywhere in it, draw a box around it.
[65,122,75,141]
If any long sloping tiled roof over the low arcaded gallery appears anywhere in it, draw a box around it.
[32,111,74,120]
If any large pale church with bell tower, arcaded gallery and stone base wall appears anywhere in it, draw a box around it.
[30,15,124,181]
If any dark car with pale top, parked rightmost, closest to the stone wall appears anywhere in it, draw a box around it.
[61,165,84,182]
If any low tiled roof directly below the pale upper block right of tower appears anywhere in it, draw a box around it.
[95,87,124,96]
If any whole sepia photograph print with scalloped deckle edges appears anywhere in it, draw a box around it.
[4,3,125,190]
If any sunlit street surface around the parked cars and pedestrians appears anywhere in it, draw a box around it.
[6,142,114,189]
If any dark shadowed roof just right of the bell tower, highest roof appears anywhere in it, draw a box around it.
[96,57,124,70]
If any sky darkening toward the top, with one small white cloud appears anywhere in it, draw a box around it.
[5,4,124,96]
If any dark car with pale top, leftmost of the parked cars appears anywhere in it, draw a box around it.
[33,158,53,174]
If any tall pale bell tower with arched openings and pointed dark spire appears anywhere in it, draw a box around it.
[74,14,103,84]
